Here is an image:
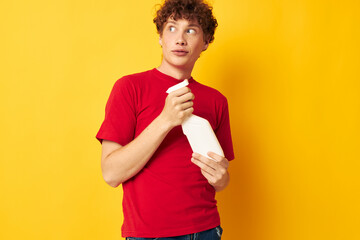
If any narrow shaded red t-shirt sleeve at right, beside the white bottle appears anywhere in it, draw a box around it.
[215,98,235,161]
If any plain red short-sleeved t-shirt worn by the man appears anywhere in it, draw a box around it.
[96,69,234,238]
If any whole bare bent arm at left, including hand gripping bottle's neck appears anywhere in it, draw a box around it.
[101,87,194,187]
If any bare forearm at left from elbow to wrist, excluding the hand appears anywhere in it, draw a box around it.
[102,115,172,187]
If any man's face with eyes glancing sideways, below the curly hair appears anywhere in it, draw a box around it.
[160,18,208,71]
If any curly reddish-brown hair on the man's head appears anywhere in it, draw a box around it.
[153,0,218,43]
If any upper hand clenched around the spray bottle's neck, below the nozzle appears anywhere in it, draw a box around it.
[159,87,195,128]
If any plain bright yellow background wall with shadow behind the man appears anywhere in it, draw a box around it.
[0,0,360,240]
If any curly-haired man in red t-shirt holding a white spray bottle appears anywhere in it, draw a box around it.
[97,0,234,240]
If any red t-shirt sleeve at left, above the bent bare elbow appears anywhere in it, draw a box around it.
[96,77,136,146]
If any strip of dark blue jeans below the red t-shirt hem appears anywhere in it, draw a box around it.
[126,226,223,240]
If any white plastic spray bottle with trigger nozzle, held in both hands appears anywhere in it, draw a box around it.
[166,79,224,158]
